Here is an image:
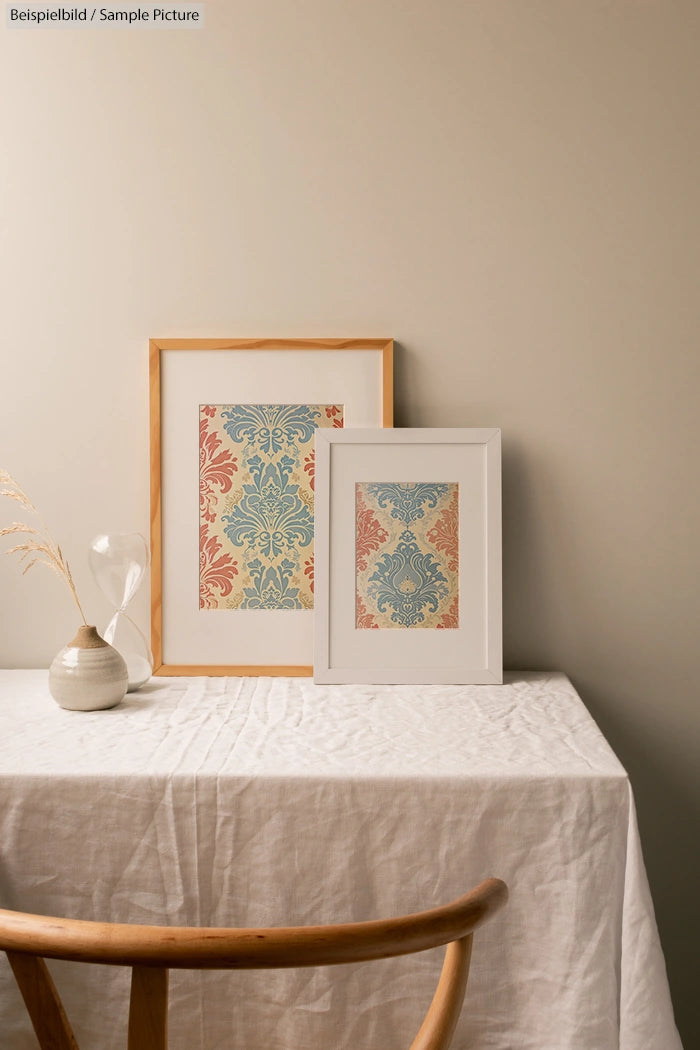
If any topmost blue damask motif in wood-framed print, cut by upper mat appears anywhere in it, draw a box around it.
[221,404,321,456]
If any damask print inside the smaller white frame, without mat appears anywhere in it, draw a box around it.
[355,482,460,629]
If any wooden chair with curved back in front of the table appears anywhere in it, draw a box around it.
[0,879,508,1050]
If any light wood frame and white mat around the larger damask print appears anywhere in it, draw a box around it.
[150,338,394,676]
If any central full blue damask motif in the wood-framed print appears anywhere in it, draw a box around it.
[221,456,314,564]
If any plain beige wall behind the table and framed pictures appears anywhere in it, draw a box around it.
[0,0,700,1050]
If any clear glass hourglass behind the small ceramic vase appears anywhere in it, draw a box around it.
[88,532,153,692]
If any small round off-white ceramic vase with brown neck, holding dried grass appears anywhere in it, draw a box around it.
[48,626,128,711]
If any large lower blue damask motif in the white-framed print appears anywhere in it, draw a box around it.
[367,533,448,627]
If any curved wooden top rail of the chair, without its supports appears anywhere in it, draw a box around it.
[0,879,508,969]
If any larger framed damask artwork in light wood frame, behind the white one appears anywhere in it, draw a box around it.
[150,339,393,675]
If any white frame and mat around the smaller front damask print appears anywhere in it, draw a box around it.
[314,427,503,685]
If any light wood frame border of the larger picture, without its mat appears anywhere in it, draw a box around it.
[149,338,394,677]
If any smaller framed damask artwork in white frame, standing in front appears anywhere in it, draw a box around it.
[314,428,503,684]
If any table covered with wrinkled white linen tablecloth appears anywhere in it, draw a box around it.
[0,671,680,1050]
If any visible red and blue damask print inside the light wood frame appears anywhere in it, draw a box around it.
[199,404,343,609]
